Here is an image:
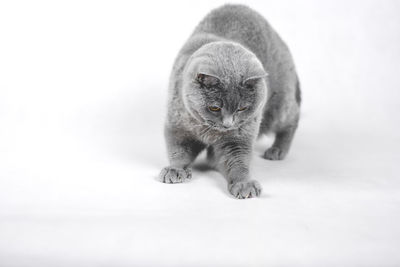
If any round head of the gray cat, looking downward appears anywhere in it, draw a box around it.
[182,42,267,131]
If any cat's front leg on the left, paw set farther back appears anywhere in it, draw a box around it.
[159,129,205,184]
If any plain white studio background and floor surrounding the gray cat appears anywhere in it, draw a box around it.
[0,0,400,267]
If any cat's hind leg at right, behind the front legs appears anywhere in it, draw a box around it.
[264,124,297,160]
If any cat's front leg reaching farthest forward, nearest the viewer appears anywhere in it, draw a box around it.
[214,139,261,199]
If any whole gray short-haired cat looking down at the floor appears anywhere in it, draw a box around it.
[159,5,300,199]
